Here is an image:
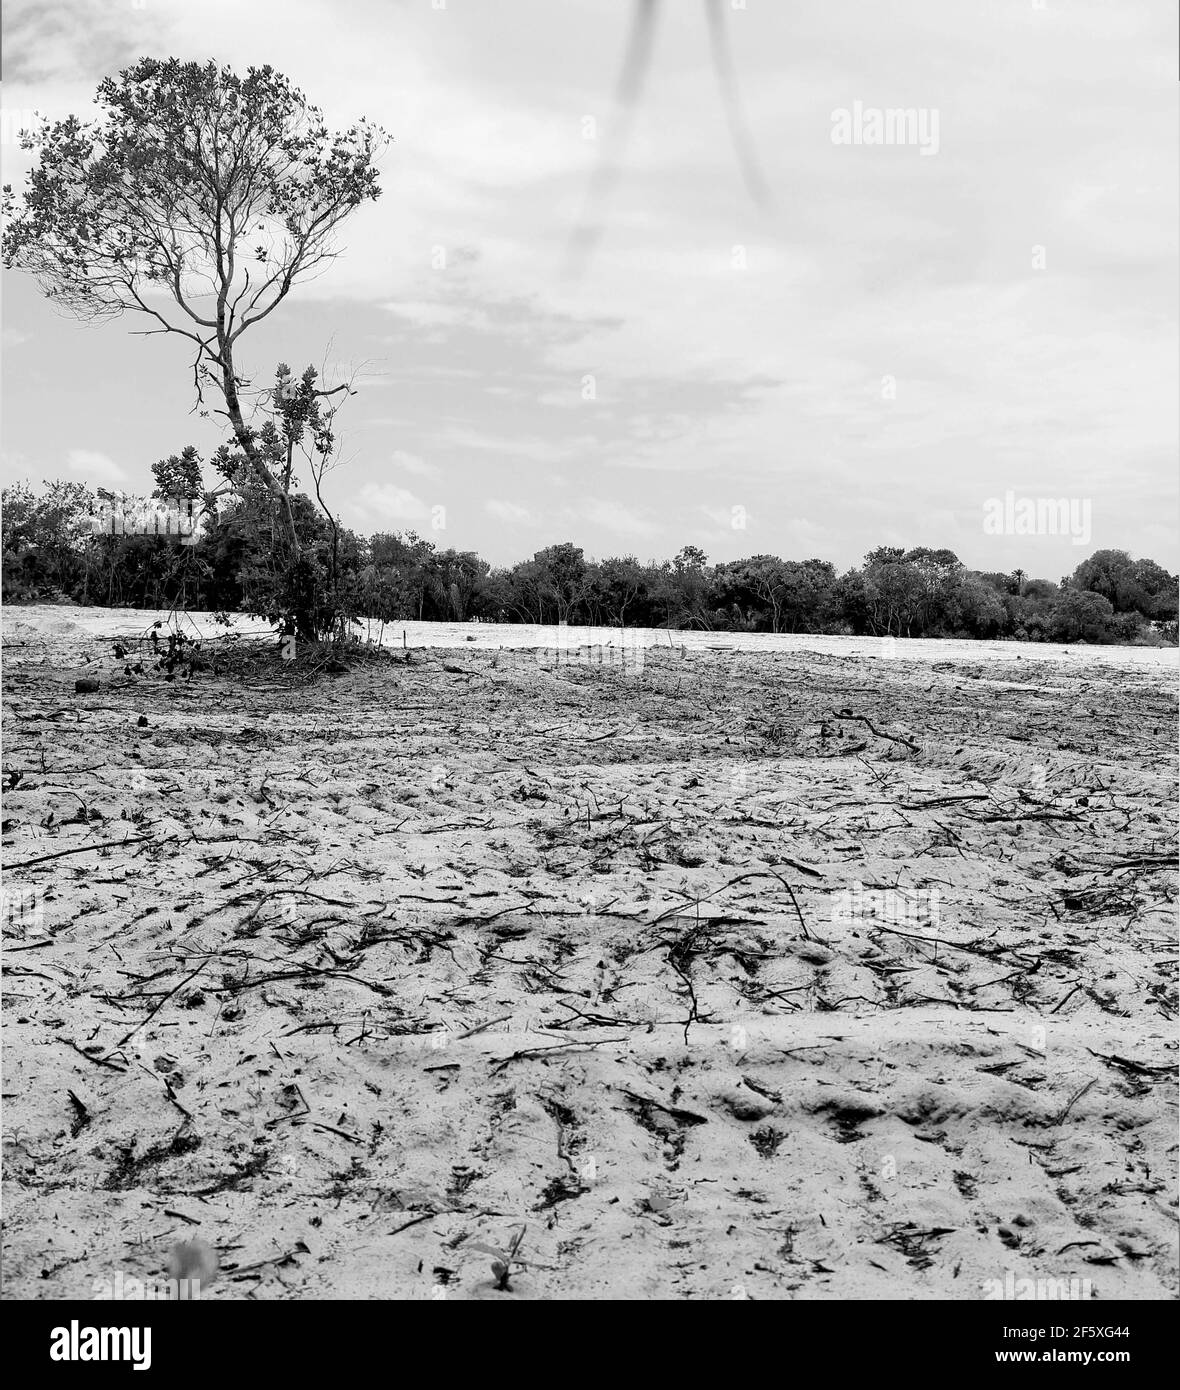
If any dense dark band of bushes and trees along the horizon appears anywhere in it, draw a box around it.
[3,464,1177,642]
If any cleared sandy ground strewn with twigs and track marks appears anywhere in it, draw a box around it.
[3,609,1177,1300]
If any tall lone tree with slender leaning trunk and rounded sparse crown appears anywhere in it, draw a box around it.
[3,58,385,637]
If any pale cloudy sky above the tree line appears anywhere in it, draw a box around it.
[0,0,1180,578]
